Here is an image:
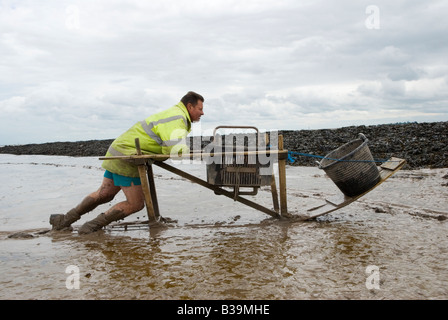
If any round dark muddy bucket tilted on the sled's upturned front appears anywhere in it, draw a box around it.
[319,133,380,197]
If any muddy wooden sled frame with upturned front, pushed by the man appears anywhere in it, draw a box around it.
[99,135,406,227]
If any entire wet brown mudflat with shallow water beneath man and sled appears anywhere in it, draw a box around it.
[0,155,448,300]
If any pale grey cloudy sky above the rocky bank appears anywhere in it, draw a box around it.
[0,0,448,145]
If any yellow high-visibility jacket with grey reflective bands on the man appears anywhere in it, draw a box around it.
[102,102,191,177]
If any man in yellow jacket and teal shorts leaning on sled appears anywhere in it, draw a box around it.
[50,91,204,234]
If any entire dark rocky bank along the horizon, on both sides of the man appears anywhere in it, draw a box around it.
[0,122,448,169]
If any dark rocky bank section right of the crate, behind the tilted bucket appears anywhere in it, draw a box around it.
[281,122,448,169]
